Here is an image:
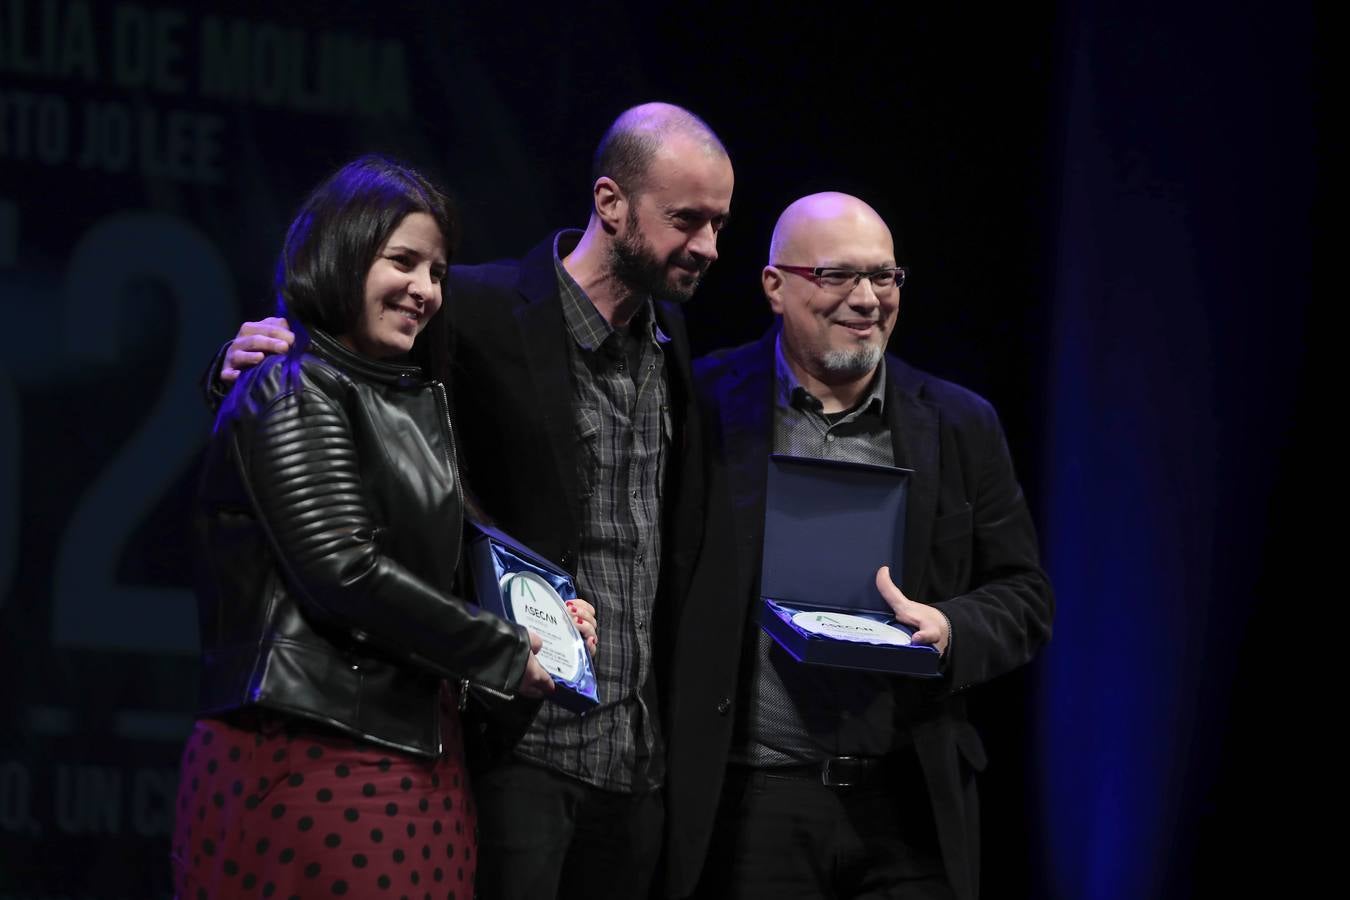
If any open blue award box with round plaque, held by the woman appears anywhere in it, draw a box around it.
[464,519,599,712]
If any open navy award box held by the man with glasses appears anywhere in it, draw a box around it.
[760,453,938,676]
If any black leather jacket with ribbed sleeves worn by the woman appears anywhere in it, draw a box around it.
[197,332,529,756]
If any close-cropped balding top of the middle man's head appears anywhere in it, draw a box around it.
[591,103,728,194]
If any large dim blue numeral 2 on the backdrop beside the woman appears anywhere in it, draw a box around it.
[51,213,235,653]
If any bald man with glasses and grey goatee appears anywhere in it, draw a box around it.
[667,193,1053,900]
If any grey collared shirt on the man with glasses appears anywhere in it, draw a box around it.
[732,337,900,766]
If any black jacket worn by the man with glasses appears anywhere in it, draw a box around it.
[667,328,1054,897]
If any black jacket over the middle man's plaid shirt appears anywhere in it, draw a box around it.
[444,235,703,753]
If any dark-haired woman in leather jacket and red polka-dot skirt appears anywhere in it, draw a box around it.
[173,157,575,900]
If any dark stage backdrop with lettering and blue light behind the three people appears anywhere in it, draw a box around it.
[0,0,1312,899]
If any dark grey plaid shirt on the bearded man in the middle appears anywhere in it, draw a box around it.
[517,232,671,792]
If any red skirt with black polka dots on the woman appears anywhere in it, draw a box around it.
[173,711,478,900]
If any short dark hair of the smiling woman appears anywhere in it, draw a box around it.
[273,154,459,379]
